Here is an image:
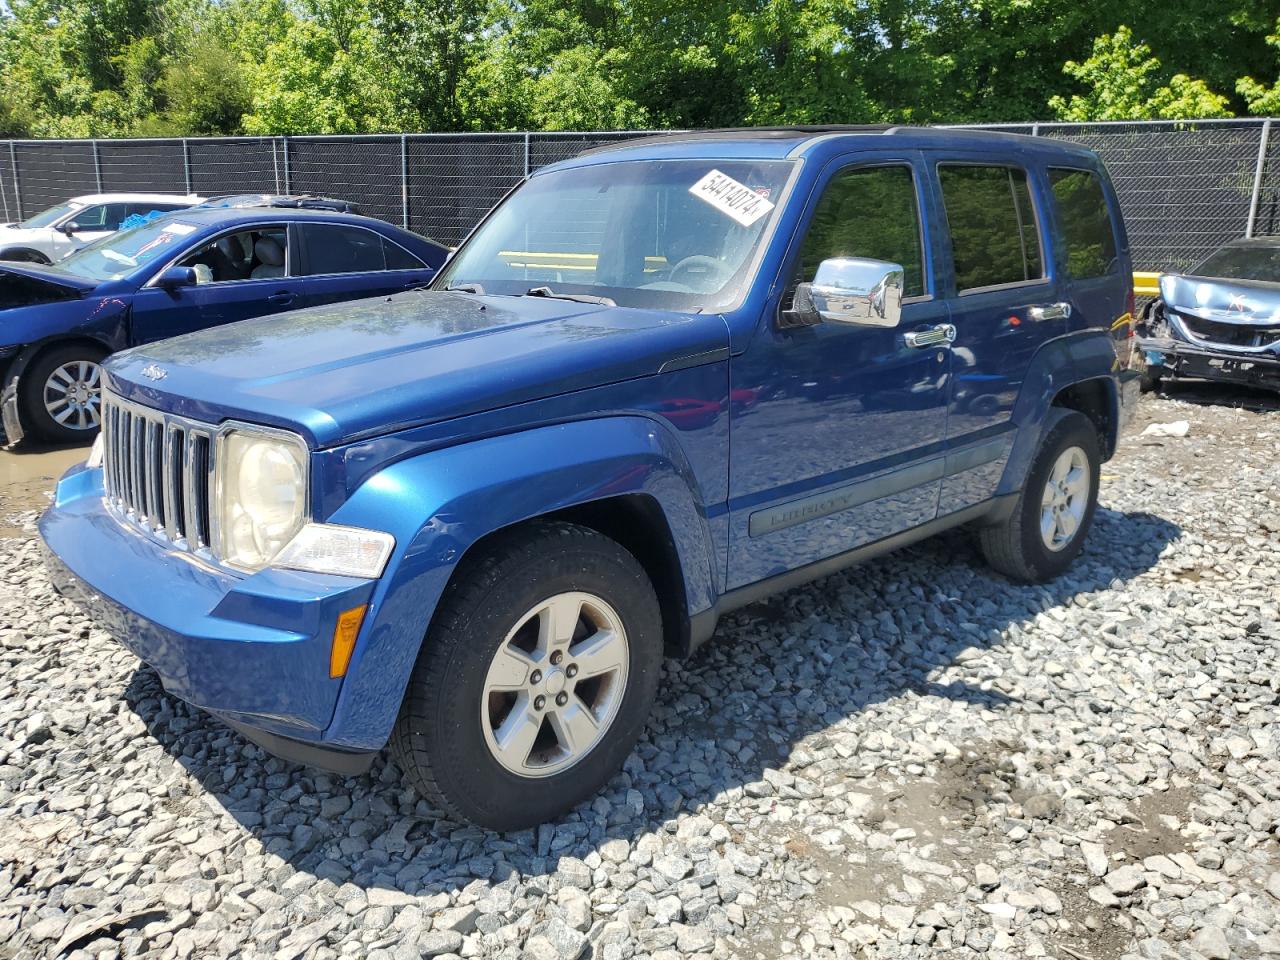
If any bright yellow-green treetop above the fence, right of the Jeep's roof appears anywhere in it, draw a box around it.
[1048,26,1231,120]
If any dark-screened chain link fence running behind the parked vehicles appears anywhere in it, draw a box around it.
[0,119,1280,270]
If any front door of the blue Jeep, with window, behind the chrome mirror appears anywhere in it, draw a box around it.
[728,152,950,588]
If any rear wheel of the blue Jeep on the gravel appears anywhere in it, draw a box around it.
[978,408,1102,584]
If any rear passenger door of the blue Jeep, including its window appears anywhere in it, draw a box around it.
[932,158,1070,515]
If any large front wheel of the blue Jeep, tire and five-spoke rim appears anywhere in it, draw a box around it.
[392,522,663,831]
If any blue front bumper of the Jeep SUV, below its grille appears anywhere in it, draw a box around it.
[40,467,374,773]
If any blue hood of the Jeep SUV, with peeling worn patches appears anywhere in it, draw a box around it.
[108,291,728,447]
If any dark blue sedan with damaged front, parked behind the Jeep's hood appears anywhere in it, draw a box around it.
[0,204,448,443]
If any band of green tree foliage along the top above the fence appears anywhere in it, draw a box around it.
[0,0,1280,137]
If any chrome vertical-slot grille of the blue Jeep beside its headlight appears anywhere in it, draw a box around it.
[102,390,216,550]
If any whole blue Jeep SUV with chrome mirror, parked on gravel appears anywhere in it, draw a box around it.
[40,127,1137,829]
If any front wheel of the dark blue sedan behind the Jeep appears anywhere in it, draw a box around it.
[18,343,106,443]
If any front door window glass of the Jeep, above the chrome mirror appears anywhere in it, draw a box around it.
[795,164,927,297]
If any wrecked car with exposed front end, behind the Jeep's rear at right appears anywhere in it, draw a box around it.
[1137,237,1280,392]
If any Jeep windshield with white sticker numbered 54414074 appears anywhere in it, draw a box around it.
[434,160,794,312]
